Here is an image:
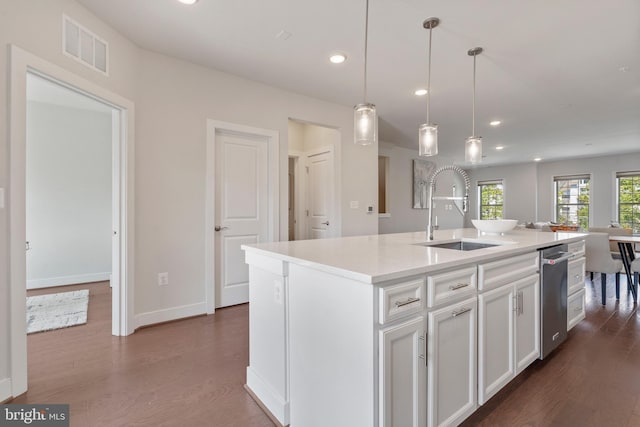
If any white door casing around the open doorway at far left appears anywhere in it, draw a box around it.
[8,46,134,396]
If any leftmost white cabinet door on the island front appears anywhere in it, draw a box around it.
[380,316,427,427]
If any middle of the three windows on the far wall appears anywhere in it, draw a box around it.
[553,175,590,230]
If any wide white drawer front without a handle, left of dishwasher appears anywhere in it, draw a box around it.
[478,252,540,291]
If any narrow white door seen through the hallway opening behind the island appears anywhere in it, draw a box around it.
[307,149,335,239]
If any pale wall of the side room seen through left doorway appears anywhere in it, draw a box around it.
[26,101,111,289]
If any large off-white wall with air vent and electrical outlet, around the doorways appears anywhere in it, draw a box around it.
[0,0,377,399]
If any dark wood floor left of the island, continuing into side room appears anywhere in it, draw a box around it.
[16,282,273,427]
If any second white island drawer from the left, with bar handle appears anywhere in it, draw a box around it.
[427,265,478,308]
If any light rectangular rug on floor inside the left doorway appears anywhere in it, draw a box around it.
[27,289,89,334]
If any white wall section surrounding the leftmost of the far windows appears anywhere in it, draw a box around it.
[465,163,538,227]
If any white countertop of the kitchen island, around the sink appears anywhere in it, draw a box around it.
[242,228,585,283]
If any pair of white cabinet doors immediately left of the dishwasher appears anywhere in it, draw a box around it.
[478,274,540,405]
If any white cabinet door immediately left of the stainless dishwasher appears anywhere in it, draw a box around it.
[514,274,540,375]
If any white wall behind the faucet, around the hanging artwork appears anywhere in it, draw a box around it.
[376,142,462,234]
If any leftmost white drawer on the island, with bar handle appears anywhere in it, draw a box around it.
[379,278,425,324]
